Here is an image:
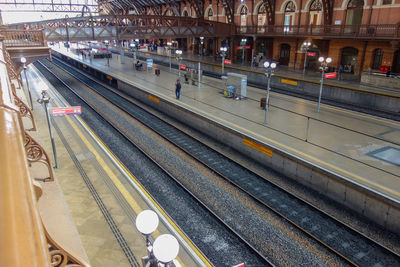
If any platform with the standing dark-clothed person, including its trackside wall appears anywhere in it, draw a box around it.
[53,47,400,237]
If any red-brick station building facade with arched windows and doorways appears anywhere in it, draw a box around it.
[144,0,400,75]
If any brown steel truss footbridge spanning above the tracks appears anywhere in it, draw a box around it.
[9,15,233,41]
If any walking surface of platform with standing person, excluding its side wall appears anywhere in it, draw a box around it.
[53,47,400,207]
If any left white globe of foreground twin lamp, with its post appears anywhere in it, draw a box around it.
[136,210,159,266]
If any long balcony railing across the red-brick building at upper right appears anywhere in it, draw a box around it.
[236,24,400,39]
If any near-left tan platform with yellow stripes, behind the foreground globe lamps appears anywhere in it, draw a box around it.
[24,60,209,266]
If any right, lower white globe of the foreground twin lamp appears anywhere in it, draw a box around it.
[153,234,179,266]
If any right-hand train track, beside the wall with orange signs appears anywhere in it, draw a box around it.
[42,56,400,266]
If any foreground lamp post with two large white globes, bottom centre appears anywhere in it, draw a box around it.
[136,210,179,267]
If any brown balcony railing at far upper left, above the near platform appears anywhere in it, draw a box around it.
[0,29,47,47]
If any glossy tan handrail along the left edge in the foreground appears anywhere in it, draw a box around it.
[0,36,50,266]
